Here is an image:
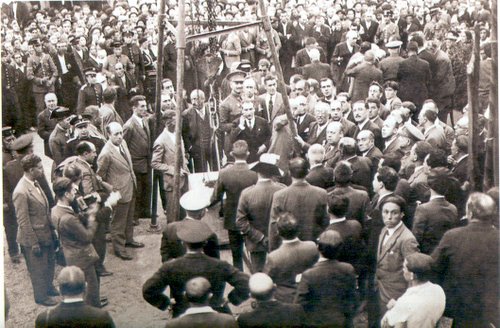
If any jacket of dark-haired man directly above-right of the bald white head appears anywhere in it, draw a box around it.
[264,239,319,303]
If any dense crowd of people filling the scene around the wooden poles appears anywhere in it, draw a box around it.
[1,0,499,327]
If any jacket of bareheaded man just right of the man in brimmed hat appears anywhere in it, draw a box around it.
[269,181,329,250]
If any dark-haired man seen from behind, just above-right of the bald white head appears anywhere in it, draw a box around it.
[264,212,319,303]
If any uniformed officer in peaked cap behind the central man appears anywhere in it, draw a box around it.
[219,70,247,161]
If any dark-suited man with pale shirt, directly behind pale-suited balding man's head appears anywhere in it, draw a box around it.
[110,62,141,120]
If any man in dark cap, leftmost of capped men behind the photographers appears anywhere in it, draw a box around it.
[49,107,71,165]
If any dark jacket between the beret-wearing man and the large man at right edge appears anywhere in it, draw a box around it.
[412,197,458,254]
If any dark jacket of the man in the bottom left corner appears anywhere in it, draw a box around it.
[35,300,115,328]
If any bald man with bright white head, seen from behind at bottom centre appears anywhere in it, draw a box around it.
[238,273,304,328]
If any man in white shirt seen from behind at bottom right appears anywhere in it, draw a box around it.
[381,253,446,328]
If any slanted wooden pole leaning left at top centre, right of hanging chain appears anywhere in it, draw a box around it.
[259,0,297,137]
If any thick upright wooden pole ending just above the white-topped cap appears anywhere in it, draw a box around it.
[172,0,186,221]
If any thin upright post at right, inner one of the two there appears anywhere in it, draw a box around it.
[467,24,482,191]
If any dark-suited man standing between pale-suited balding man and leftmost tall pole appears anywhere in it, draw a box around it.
[123,96,151,224]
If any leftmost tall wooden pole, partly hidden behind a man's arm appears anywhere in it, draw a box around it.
[149,0,166,232]
